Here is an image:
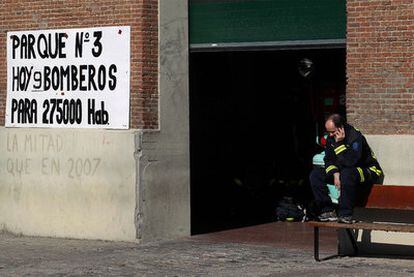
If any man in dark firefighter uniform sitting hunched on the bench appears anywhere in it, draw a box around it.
[310,114,384,223]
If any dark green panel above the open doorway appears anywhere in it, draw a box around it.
[189,0,346,44]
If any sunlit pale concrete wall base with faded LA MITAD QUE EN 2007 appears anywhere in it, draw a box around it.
[0,128,137,240]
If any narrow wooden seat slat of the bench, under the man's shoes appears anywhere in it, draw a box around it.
[308,221,414,233]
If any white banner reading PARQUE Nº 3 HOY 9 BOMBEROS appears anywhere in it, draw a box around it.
[6,26,130,129]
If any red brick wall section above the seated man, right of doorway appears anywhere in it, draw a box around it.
[347,0,414,134]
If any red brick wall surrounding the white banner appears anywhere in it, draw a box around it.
[0,0,158,129]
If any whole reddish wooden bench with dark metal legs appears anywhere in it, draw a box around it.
[308,185,414,262]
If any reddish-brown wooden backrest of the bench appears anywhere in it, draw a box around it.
[365,185,414,210]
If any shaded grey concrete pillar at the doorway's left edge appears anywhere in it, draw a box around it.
[138,0,190,241]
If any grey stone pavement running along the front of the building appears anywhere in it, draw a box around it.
[0,223,414,277]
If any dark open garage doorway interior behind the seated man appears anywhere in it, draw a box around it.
[190,49,346,234]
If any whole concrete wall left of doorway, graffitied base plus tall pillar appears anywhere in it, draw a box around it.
[0,0,190,241]
